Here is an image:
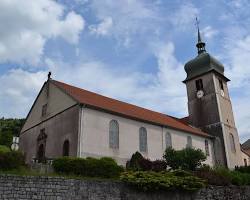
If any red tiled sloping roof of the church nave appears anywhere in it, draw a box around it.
[50,80,212,137]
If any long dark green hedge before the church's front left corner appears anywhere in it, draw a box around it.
[53,157,123,178]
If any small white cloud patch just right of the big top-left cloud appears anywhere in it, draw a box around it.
[89,17,113,35]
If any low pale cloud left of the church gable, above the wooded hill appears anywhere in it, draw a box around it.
[0,69,46,118]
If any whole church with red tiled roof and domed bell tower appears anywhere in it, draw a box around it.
[20,29,250,168]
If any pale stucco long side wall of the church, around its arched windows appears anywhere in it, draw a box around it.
[79,108,213,165]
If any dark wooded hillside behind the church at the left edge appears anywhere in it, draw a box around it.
[0,118,25,147]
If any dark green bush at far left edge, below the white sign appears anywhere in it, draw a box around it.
[0,151,25,170]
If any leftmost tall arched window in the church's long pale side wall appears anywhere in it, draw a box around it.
[109,120,119,149]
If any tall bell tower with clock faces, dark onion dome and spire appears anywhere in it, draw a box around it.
[183,22,241,168]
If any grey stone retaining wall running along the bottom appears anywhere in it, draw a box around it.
[0,175,250,200]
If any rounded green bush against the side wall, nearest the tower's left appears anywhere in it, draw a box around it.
[163,148,206,171]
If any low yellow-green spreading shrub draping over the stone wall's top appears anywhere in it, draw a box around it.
[120,171,205,191]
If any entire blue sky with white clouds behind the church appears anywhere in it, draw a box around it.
[0,0,250,141]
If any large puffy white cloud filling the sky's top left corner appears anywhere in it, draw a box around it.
[0,0,84,64]
